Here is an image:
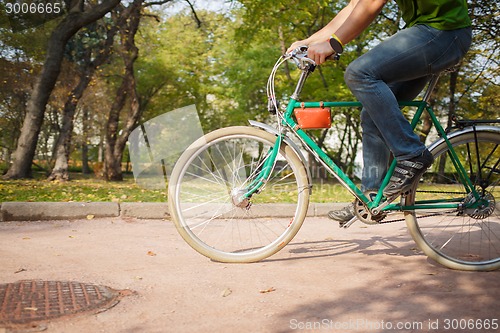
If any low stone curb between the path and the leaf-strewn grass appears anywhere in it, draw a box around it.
[0,202,346,222]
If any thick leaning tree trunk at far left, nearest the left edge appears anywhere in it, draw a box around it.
[5,0,120,179]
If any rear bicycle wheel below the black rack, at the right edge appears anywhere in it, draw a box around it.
[405,130,500,271]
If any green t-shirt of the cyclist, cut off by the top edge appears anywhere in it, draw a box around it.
[396,0,471,30]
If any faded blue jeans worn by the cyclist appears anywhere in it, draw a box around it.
[344,25,472,190]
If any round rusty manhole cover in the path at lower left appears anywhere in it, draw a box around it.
[0,280,120,327]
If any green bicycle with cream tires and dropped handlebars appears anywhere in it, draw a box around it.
[168,48,500,271]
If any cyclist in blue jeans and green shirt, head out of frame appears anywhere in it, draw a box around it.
[289,0,472,224]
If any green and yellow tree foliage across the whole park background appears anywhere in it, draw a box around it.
[0,0,500,186]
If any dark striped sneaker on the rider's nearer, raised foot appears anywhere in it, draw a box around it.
[384,149,434,198]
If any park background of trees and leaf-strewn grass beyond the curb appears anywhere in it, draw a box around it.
[0,0,500,202]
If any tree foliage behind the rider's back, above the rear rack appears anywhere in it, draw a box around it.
[421,1,500,147]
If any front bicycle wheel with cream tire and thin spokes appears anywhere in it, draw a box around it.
[168,126,310,263]
